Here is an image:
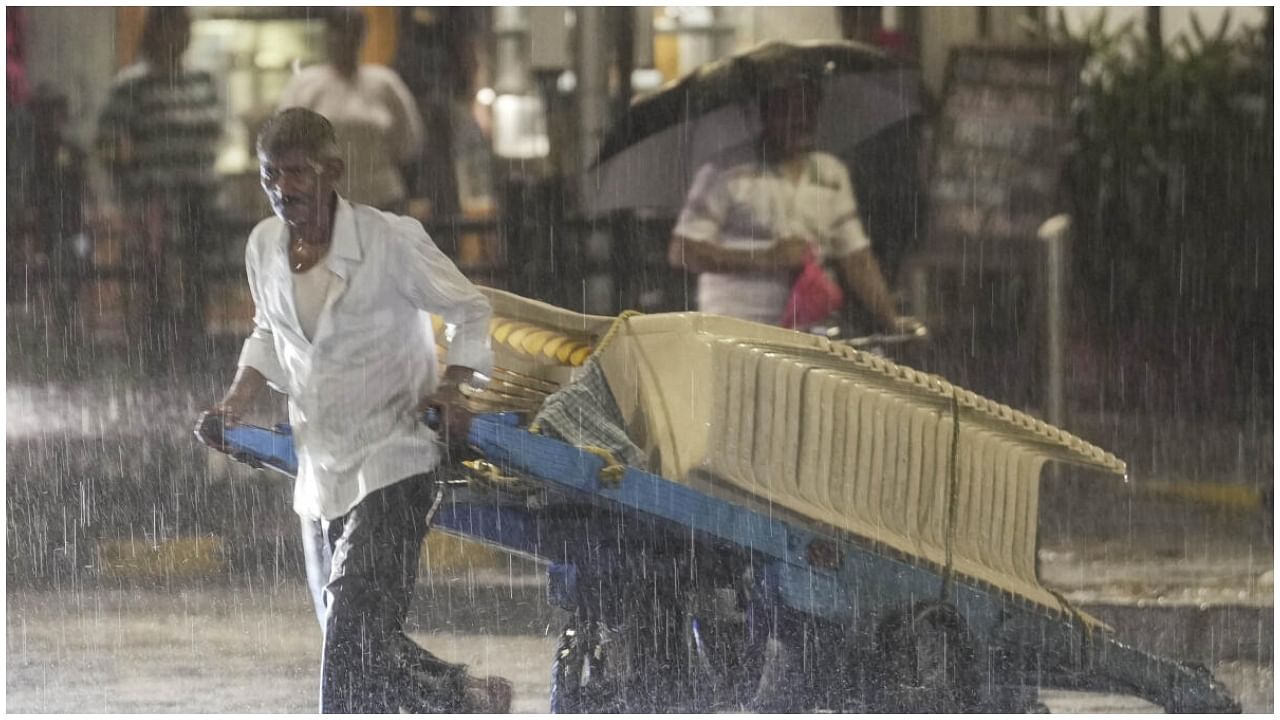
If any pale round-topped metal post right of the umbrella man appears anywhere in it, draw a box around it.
[1037,214,1071,427]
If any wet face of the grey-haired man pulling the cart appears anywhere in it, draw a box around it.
[257,150,342,228]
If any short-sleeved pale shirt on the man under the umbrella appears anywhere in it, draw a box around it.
[675,152,870,325]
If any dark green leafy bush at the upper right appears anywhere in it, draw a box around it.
[1052,12,1274,334]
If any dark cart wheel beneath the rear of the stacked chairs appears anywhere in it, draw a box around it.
[876,602,978,714]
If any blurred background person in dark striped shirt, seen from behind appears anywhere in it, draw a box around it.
[97,6,223,369]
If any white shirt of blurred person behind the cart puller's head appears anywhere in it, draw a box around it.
[279,64,422,210]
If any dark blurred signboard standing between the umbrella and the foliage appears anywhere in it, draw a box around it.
[905,46,1080,410]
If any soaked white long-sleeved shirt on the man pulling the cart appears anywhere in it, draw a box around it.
[239,197,493,519]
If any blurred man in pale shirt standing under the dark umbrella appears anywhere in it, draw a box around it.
[668,74,924,334]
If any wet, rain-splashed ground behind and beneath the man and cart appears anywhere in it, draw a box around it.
[6,333,1274,712]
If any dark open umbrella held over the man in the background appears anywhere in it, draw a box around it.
[584,42,922,215]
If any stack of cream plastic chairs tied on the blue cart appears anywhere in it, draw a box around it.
[445,291,1125,609]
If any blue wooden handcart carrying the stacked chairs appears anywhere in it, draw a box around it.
[197,414,1239,712]
